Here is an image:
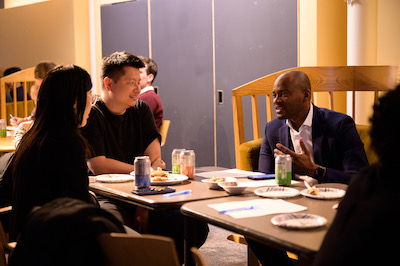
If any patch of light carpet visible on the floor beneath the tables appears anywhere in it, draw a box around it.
[200,224,247,266]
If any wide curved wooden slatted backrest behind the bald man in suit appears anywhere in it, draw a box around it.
[232,66,400,167]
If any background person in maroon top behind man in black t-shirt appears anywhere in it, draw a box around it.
[138,56,164,129]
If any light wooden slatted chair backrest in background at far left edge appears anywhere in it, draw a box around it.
[0,67,35,123]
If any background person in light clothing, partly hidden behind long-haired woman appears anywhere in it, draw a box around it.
[10,61,56,147]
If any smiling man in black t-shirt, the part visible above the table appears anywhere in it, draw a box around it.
[82,52,165,172]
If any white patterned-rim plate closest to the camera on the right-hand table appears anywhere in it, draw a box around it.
[271,213,327,229]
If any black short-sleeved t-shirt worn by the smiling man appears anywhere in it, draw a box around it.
[81,100,160,164]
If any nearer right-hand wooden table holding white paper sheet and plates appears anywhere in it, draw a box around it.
[181,183,347,265]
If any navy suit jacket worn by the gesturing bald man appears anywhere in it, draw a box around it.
[259,105,368,184]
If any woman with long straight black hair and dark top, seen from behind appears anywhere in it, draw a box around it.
[10,65,94,239]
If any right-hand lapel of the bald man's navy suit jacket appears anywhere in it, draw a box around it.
[312,104,326,164]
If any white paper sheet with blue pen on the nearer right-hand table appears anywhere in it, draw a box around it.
[207,199,307,219]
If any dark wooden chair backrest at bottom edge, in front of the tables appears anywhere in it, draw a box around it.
[98,233,179,266]
